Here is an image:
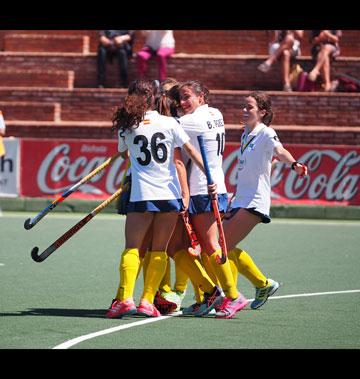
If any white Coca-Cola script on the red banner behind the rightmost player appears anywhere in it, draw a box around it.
[223,149,360,201]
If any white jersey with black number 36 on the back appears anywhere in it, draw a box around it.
[118,111,189,202]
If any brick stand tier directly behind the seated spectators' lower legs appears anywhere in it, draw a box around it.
[0,52,360,90]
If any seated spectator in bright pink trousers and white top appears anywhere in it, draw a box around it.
[137,30,175,82]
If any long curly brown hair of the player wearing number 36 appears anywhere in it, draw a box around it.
[112,79,157,136]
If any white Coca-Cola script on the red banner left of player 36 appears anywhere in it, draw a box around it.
[37,143,124,195]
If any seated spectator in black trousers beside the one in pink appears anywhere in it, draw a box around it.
[97,30,135,88]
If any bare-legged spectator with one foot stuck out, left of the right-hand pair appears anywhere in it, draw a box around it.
[258,30,304,92]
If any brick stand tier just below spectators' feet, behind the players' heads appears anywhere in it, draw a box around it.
[0,88,360,126]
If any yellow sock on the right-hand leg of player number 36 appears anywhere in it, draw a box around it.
[141,251,167,303]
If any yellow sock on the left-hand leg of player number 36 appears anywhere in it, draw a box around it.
[116,249,140,301]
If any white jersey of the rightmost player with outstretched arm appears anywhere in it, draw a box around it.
[232,124,282,215]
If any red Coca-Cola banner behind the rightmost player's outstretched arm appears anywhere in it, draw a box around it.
[223,143,360,205]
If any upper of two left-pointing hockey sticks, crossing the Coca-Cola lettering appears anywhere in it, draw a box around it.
[24,153,120,230]
